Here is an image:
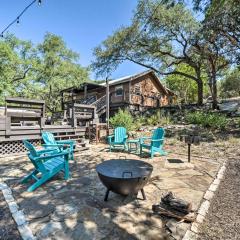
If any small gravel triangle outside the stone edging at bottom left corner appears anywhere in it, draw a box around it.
[0,191,21,240]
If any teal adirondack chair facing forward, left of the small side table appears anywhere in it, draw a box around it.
[108,127,127,152]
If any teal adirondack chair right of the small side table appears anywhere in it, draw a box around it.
[140,128,167,158]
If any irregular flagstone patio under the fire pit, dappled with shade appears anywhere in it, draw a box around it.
[0,139,226,240]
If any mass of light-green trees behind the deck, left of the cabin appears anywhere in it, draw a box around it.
[0,33,89,112]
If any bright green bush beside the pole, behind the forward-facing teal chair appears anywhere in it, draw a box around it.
[109,109,135,131]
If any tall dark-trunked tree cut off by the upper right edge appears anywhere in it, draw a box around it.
[195,0,240,108]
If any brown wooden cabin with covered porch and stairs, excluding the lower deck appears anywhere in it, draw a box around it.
[61,70,176,124]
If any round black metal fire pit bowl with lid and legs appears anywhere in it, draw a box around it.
[96,159,153,201]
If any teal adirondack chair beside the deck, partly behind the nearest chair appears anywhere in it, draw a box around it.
[42,132,76,160]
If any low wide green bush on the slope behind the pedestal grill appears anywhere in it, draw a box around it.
[185,111,228,130]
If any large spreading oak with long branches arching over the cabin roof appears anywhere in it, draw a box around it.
[92,0,206,104]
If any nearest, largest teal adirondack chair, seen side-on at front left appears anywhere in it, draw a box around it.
[21,140,69,192]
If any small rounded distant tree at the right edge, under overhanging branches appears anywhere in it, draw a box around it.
[220,68,240,98]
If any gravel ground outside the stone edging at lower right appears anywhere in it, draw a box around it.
[199,159,240,240]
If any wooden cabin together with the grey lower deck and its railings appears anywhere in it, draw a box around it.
[0,71,176,155]
